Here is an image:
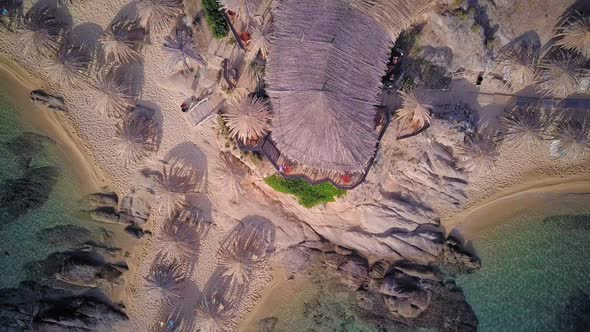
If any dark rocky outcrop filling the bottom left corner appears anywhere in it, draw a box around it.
[0,282,128,332]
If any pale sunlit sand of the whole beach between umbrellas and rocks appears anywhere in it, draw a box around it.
[0,0,590,331]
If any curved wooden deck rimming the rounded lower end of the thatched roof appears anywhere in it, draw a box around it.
[237,110,389,190]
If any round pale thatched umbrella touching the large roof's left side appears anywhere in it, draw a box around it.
[221,95,272,142]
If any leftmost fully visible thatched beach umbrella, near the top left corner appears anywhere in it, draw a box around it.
[19,7,62,55]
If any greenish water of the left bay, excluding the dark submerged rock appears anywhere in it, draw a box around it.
[0,88,104,288]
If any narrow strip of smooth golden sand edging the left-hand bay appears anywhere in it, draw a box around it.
[0,57,110,193]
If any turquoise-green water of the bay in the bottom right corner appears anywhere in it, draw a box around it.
[458,210,590,331]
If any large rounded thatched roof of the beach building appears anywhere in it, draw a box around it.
[266,0,424,171]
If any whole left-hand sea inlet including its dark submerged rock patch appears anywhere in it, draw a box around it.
[0,80,122,288]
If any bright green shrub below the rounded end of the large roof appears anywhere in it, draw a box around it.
[264,174,346,208]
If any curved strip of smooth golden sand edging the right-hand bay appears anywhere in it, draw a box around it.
[441,174,590,240]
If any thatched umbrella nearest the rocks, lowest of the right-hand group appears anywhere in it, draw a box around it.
[458,133,498,176]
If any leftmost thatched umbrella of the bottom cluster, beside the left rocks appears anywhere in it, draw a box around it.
[145,257,185,304]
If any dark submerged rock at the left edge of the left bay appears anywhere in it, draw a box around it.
[0,166,59,221]
